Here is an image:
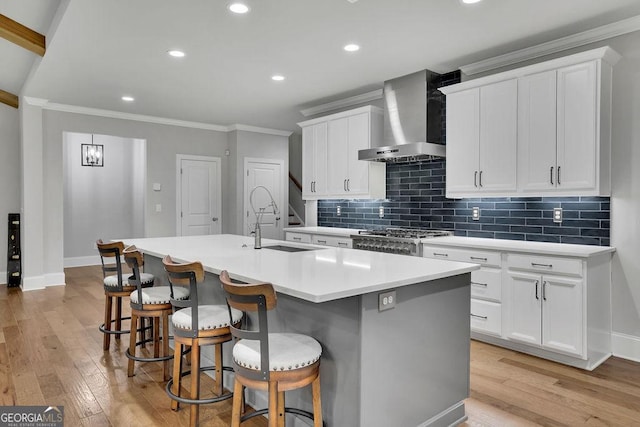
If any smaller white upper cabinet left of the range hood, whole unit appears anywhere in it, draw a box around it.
[298,106,386,199]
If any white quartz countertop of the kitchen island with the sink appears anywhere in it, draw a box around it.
[123,234,480,303]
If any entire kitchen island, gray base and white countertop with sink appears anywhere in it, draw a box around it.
[125,235,479,427]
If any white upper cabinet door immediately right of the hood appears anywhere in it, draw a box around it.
[447,88,480,195]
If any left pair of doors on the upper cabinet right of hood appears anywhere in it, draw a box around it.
[446,79,518,198]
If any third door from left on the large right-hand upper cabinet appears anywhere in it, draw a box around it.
[517,70,557,192]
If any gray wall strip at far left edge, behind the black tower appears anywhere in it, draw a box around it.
[0,104,20,283]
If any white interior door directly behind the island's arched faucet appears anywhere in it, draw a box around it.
[244,158,288,240]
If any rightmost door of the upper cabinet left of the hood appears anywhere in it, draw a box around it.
[346,113,370,194]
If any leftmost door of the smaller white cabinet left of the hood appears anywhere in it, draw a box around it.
[302,122,327,199]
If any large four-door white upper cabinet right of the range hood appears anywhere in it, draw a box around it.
[441,47,620,197]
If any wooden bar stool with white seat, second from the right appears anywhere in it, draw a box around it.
[162,255,242,426]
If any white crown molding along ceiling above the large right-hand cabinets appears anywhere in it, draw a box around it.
[460,15,640,76]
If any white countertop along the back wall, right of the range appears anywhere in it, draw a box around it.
[422,236,616,258]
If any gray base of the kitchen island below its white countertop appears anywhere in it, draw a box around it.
[125,236,475,427]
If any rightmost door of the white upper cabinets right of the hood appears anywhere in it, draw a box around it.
[557,61,599,190]
